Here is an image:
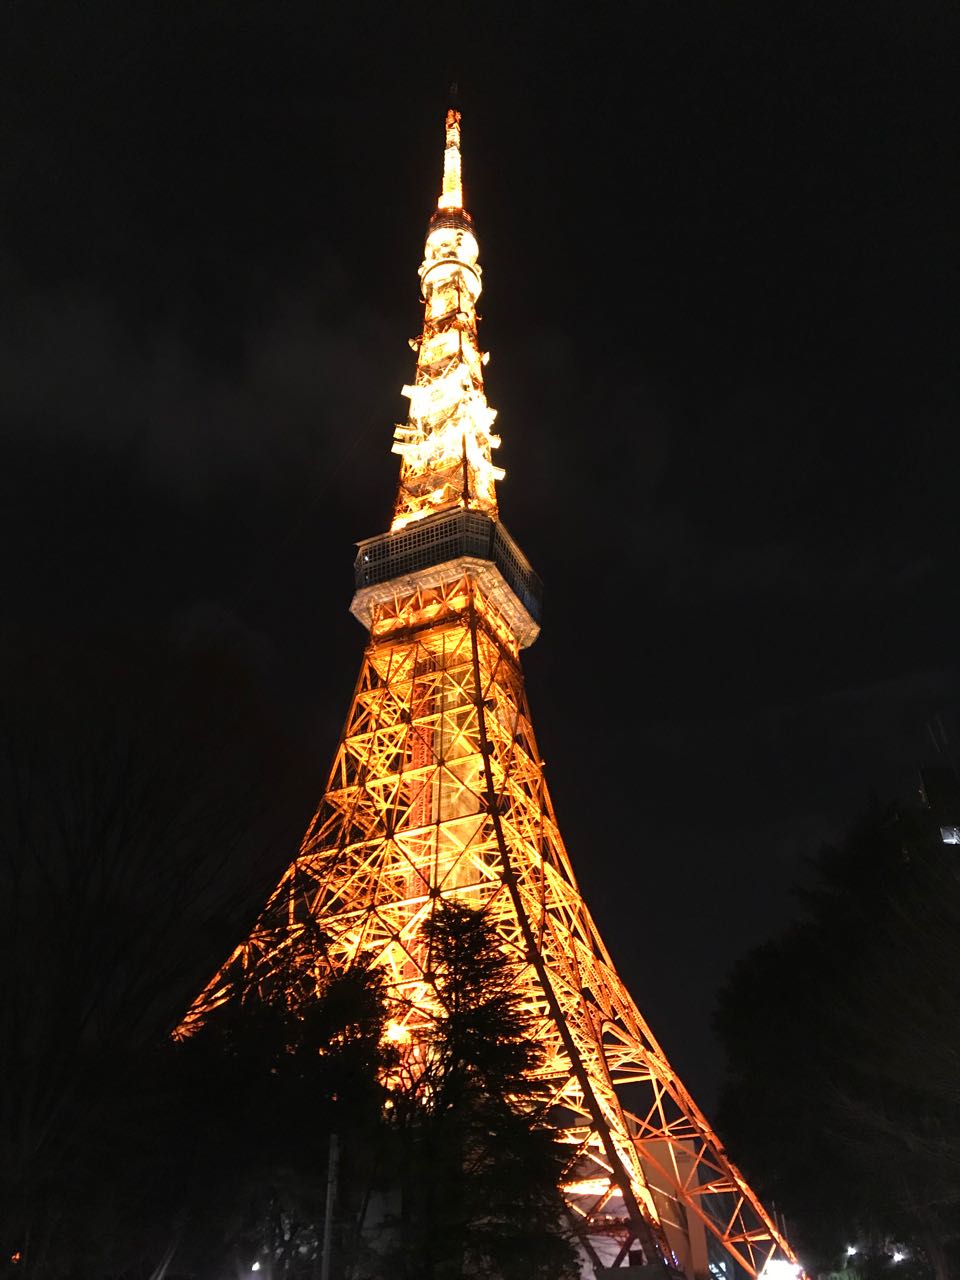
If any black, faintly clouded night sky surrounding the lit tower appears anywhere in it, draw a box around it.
[0,0,960,1108]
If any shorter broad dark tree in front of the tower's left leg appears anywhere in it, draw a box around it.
[166,962,388,1280]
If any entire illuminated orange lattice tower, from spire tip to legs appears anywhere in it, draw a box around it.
[184,111,795,1280]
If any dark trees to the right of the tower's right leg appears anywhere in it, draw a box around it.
[716,778,960,1280]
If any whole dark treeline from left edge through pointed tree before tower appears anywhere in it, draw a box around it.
[0,635,576,1280]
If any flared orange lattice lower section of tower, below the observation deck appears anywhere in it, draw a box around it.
[184,560,792,1280]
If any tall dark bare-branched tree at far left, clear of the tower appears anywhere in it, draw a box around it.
[0,624,316,1277]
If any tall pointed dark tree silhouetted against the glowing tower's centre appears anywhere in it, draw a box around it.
[381,901,577,1280]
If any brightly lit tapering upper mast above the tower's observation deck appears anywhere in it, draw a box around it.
[390,106,503,532]
